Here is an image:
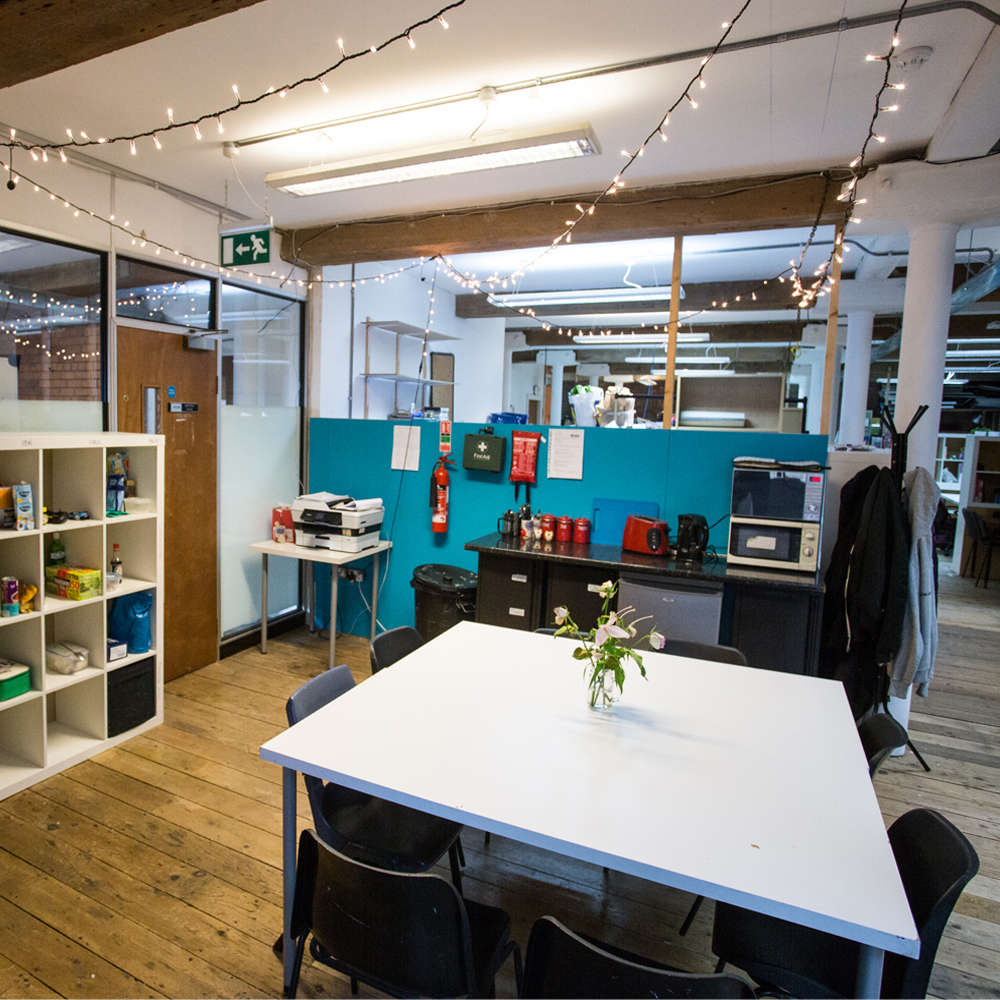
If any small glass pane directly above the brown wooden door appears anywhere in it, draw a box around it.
[115,257,214,330]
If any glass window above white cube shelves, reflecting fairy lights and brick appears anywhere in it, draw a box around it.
[0,231,105,431]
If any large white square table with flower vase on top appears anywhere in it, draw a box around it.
[261,622,920,996]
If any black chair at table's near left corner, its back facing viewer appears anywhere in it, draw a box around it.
[288,830,521,997]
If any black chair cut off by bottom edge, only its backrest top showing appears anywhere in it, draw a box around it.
[520,917,756,998]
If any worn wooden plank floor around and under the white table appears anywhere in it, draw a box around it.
[0,578,1000,997]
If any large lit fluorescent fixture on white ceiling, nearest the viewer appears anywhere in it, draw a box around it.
[264,122,601,196]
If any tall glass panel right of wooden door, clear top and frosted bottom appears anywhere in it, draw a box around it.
[219,283,303,638]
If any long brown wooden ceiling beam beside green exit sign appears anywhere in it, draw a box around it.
[281,173,844,267]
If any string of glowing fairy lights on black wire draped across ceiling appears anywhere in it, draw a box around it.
[0,0,908,358]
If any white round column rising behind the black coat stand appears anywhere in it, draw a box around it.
[893,222,958,472]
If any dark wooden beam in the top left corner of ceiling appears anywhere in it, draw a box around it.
[0,0,270,87]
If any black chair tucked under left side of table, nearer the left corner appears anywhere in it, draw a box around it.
[285,664,462,892]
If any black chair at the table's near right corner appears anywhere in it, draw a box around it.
[712,809,979,997]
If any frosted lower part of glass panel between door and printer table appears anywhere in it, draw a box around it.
[219,406,301,636]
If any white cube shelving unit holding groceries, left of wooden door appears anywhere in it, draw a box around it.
[0,432,163,799]
